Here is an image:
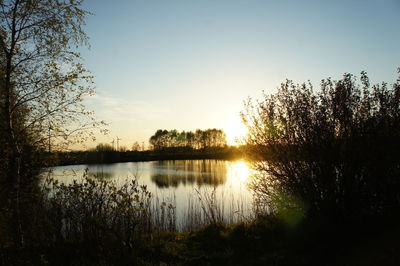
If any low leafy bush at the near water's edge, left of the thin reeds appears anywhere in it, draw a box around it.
[43,172,151,248]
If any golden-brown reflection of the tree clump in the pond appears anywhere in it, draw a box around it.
[150,160,228,188]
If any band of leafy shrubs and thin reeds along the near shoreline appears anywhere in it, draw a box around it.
[39,172,253,237]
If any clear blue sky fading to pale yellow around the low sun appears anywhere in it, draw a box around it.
[81,0,400,149]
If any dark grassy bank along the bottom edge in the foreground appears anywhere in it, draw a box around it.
[2,216,400,265]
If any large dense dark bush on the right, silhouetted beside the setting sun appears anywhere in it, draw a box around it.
[242,72,400,217]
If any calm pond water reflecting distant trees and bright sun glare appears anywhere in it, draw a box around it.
[43,160,252,227]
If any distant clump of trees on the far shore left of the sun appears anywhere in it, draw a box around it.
[149,128,227,150]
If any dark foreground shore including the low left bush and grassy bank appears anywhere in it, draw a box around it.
[0,175,400,265]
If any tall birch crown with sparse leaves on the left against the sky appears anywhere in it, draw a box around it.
[0,0,103,178]
